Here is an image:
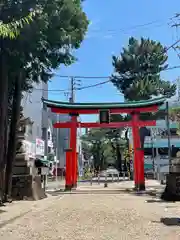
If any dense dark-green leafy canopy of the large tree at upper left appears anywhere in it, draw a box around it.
[0,0,88,81]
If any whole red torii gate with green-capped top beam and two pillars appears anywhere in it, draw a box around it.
[43,98,165,190]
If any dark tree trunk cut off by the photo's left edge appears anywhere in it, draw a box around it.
[0,51,8,204]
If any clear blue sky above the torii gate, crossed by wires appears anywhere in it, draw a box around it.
[49,0,180,121]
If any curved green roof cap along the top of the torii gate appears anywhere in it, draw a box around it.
[43,97,166,109]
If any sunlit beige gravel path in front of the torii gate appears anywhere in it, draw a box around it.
[0,193,180,240]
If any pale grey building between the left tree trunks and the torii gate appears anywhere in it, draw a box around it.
[21,82,53,156]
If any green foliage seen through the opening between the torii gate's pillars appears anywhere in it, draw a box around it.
[82,115,125,170]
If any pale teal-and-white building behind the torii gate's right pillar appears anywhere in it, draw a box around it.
[129,98,180,172]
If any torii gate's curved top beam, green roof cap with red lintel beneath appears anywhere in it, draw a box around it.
[43,97,166,114]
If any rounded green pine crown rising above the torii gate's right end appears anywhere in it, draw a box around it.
[112,37,176,101]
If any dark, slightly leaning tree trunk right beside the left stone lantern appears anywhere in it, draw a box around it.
[5,72,22,199]
